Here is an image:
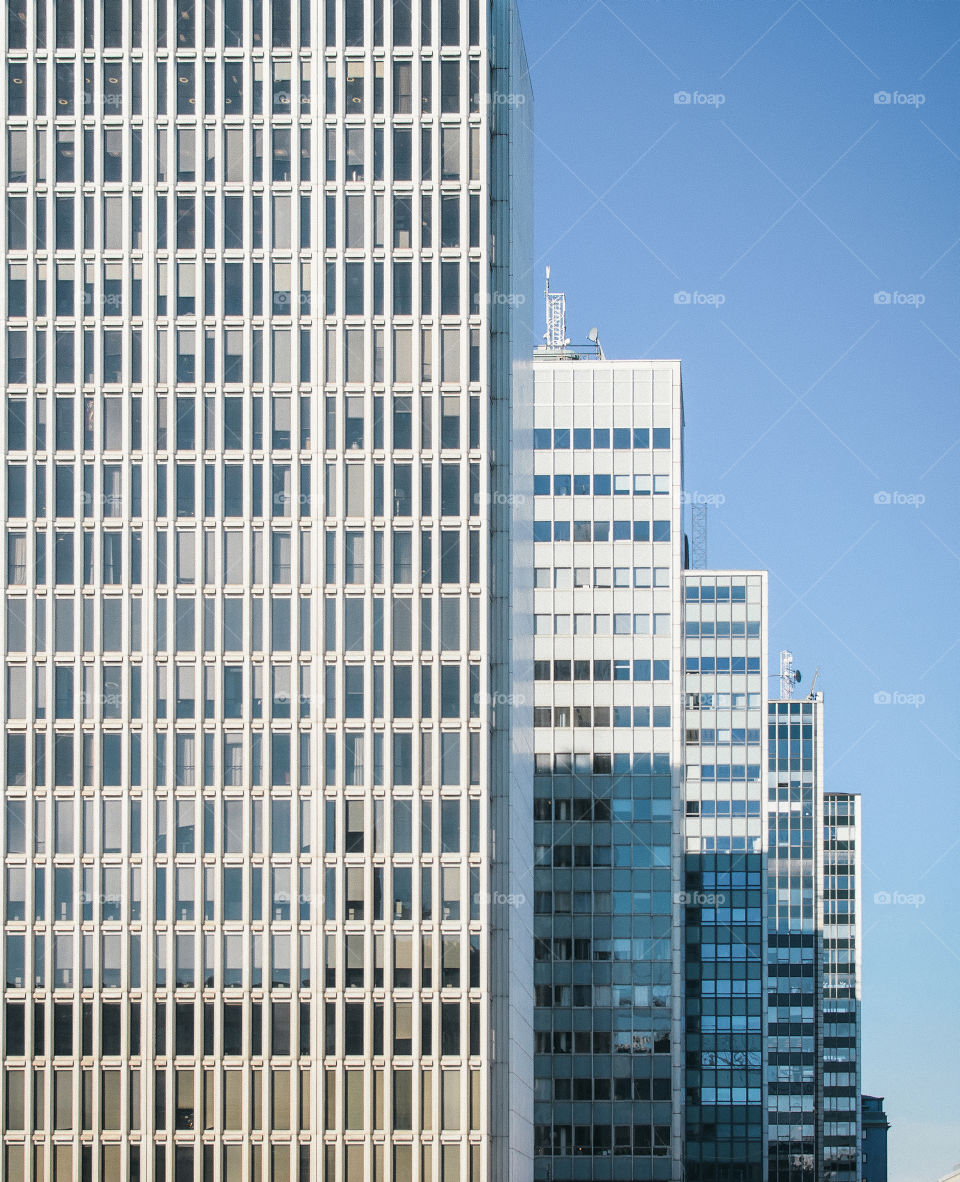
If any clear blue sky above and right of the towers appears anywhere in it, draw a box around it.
[520,0,960,1182]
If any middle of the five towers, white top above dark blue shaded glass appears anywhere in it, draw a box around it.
[685,571,767,1182]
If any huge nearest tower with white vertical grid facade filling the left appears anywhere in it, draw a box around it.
[0,0,532,1182]
